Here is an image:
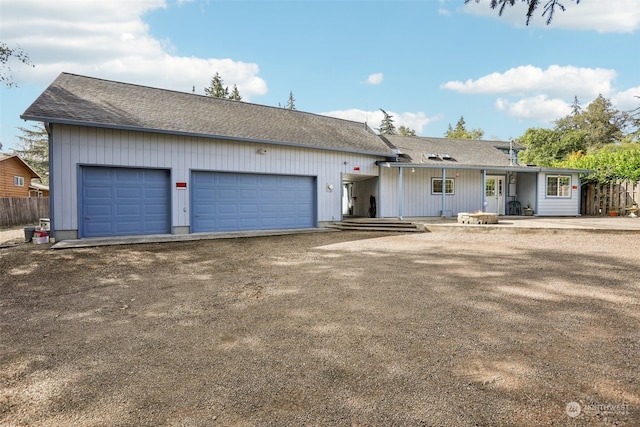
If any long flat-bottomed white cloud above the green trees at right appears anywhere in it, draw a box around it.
[440,65,616,99]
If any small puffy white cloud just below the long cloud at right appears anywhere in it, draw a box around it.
[495,95,571,122]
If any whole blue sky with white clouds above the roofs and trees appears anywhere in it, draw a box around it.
[0,0,640,152]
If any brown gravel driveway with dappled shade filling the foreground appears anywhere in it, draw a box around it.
[0,232,640,427]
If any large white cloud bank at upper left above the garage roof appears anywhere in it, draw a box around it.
[0,0,267,101]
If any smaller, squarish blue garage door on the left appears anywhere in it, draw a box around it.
[80,167,171,237]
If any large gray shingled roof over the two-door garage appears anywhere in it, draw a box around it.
[20,73,393,156]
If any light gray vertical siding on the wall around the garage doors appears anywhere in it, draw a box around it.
[51,124,380,235]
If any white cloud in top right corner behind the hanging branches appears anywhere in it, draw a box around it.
[460,0,640,33]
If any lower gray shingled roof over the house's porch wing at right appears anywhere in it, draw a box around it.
[385,135,526,168]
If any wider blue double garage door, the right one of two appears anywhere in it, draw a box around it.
[191,172,316,233]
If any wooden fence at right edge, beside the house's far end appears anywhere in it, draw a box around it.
[580,181,640,215]
